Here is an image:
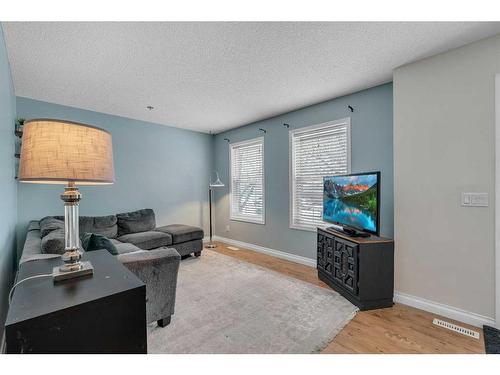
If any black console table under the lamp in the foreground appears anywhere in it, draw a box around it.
[5,250,147,353]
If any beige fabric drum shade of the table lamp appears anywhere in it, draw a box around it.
[19,119,115,185]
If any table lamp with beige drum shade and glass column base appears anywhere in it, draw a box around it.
[19,119,114,281]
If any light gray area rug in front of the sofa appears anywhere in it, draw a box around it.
[148,250,357,353]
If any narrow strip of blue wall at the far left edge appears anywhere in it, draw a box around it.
[0,26,17,337]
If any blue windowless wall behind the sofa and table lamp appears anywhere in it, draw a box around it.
[17,97,213,254]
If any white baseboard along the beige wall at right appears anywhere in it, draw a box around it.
[394,291,495,328]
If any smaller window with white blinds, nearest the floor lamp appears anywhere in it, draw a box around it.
[230,138,265,224]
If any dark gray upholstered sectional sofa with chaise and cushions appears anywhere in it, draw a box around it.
[20,209,204,327]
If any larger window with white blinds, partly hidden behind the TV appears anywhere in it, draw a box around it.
[290,118,351,230]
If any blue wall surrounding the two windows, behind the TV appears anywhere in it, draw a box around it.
[214,83,394,259]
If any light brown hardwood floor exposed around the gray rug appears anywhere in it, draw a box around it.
[205,242,484,354]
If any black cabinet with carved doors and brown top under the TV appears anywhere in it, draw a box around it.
[317,228,394,310]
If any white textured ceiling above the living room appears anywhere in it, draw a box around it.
[3,22,500,133]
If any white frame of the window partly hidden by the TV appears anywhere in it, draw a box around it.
[288,117,351,232]
